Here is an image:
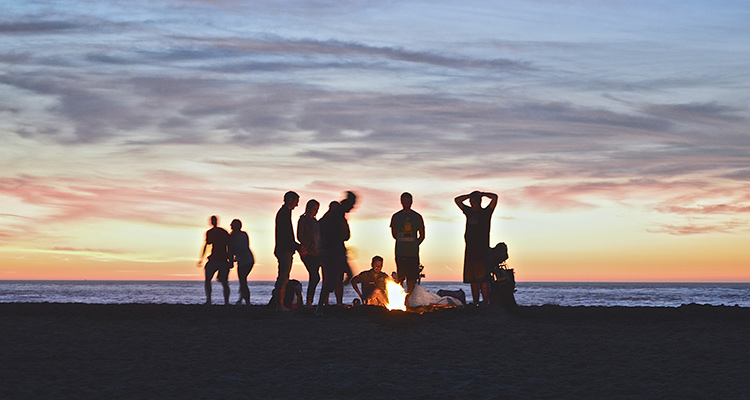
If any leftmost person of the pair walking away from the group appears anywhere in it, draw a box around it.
[198,215,232,305]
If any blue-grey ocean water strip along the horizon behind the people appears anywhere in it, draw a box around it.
[0,281,750,307]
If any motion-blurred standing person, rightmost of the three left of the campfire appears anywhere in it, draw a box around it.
[315,192,357,316]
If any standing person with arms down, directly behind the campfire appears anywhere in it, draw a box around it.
[391,192,424,293]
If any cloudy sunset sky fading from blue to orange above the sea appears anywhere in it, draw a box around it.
[0,0,750,282]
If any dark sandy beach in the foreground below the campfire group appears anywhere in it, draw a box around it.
[0,304,750,399]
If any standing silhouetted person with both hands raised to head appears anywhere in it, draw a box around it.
[455,191,497,305]
